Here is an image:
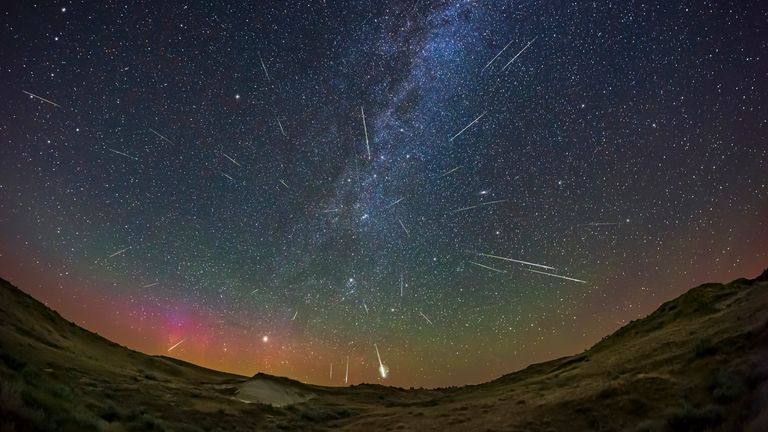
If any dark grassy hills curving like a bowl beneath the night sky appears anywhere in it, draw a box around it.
[0,271,768,432]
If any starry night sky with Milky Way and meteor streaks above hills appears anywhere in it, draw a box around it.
[0,0,768,387]
